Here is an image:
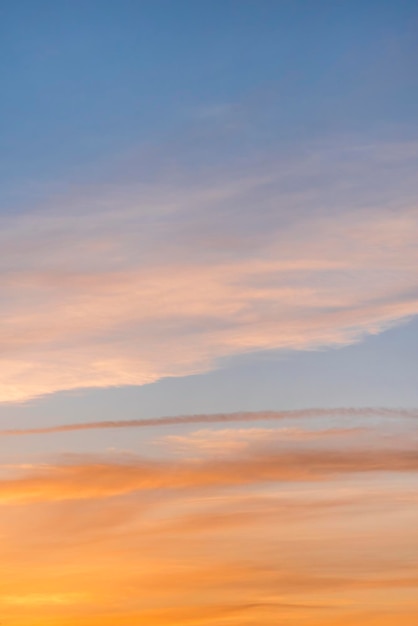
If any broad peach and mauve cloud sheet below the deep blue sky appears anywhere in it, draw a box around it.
[0,138,418,402]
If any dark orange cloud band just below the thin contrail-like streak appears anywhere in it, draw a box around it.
[0,447,418,503]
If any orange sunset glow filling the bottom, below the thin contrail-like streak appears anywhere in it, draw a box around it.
[0,416,418,626]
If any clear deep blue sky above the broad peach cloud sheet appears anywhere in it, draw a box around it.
[0,0,417,189]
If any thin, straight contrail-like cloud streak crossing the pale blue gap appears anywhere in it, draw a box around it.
[0,407,418,437]
